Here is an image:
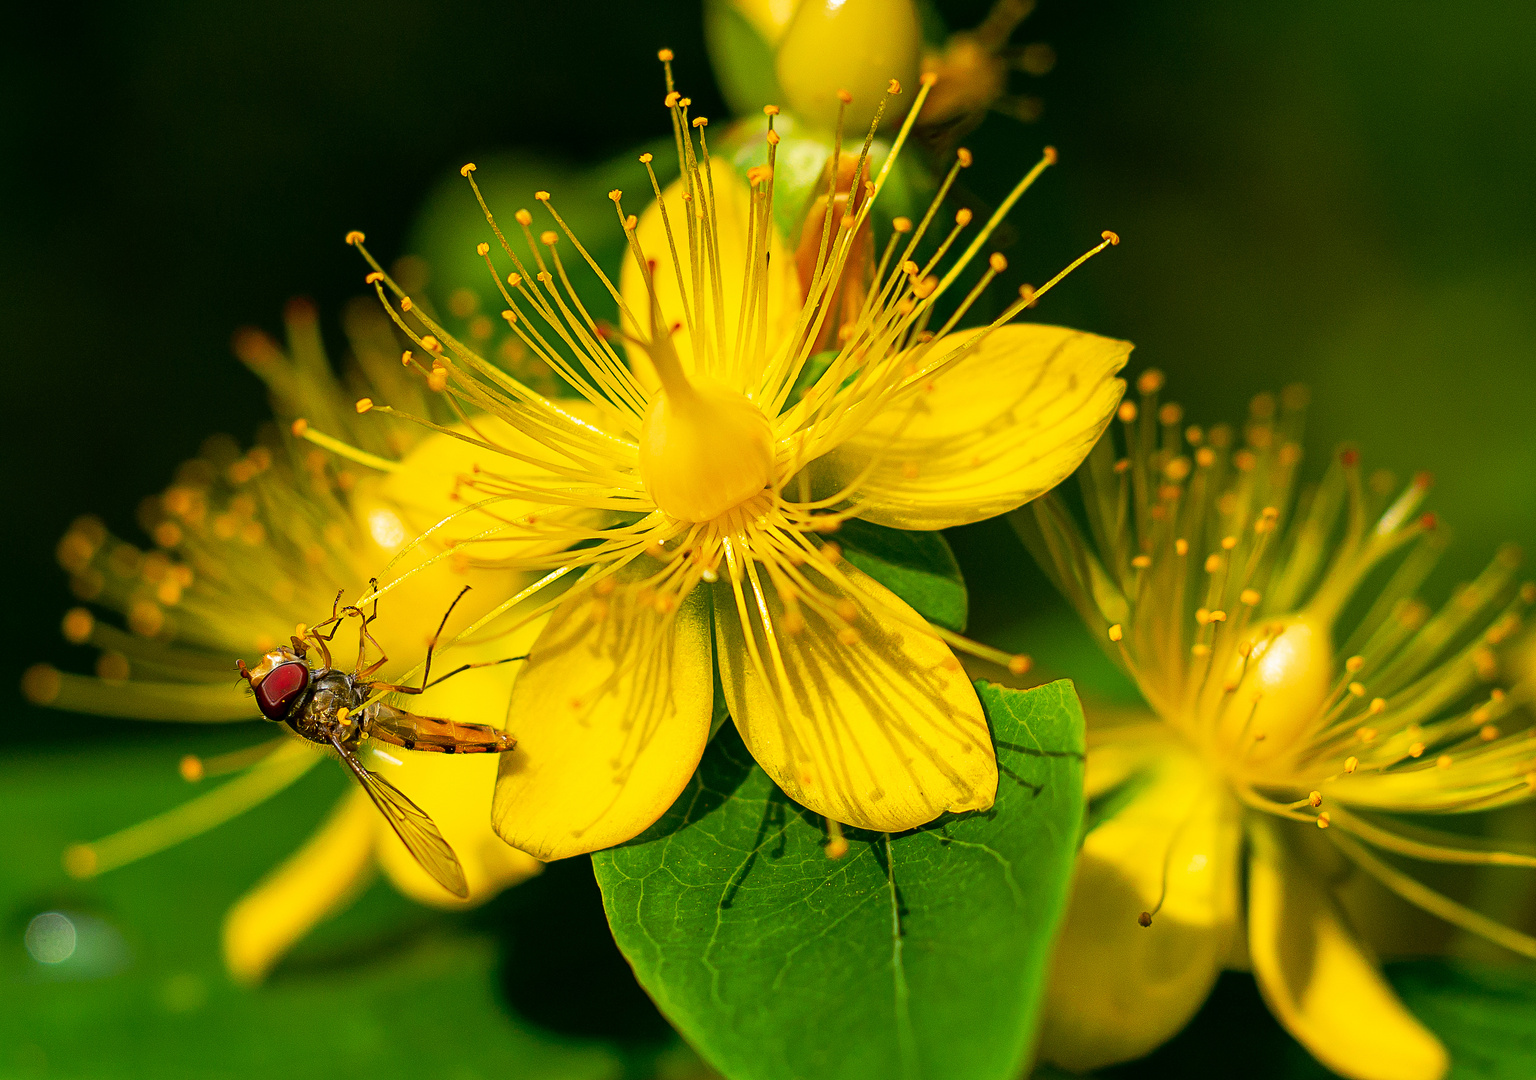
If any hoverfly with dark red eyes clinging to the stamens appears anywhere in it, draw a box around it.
[235,581,525,897]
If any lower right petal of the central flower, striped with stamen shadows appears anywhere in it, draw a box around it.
[714,556,997,833]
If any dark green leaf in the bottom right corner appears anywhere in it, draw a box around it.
[1387,960,1536,1080]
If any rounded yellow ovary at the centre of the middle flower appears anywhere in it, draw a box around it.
[641,378,776,521]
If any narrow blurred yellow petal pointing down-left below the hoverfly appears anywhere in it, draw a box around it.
[224,790,378,983]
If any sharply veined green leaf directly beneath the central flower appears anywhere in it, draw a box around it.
[593,681,1083,1080]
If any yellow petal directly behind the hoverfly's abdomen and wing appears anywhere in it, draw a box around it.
[361,619,545,908]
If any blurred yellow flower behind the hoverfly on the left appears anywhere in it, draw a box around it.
[25,304,538,980]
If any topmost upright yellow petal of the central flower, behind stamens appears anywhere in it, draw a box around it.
[619,158,800,393]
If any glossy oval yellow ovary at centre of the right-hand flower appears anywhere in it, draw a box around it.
[1213,615,1333,773]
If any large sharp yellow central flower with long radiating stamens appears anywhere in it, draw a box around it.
[349,65,1130,859]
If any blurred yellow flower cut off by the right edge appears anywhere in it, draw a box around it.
[1014,372,1536,1080]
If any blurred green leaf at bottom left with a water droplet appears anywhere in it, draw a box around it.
[0,725,676,1080]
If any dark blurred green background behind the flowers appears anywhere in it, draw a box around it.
[0,0,1536,1072]
